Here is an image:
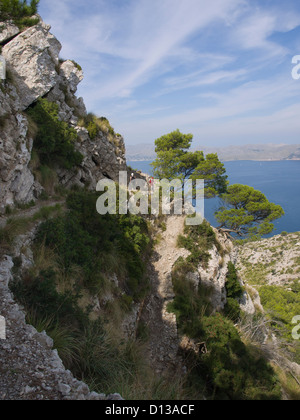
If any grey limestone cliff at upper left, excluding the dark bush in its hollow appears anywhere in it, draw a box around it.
[0,19,126,212]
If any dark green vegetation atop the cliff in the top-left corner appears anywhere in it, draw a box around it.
[0,0,39,29]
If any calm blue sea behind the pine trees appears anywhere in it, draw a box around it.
[127,161,300,236]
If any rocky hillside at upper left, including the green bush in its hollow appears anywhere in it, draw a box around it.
[0,18,127,212]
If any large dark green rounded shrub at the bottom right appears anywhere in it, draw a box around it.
[192,314,281,400]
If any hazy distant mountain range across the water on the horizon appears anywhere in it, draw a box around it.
[126,144,300,162]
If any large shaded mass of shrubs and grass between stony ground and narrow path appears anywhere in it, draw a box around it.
[11,190,163,398]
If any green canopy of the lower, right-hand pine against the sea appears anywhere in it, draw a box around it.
[215,184,284,240]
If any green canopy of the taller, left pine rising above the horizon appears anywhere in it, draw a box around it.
[152,130,227,198]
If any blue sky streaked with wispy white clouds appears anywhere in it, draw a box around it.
[39,0,300,147]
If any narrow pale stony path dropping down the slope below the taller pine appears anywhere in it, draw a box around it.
[141,216,189,374]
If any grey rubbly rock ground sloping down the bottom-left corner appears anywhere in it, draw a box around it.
[0,236,122,400]
